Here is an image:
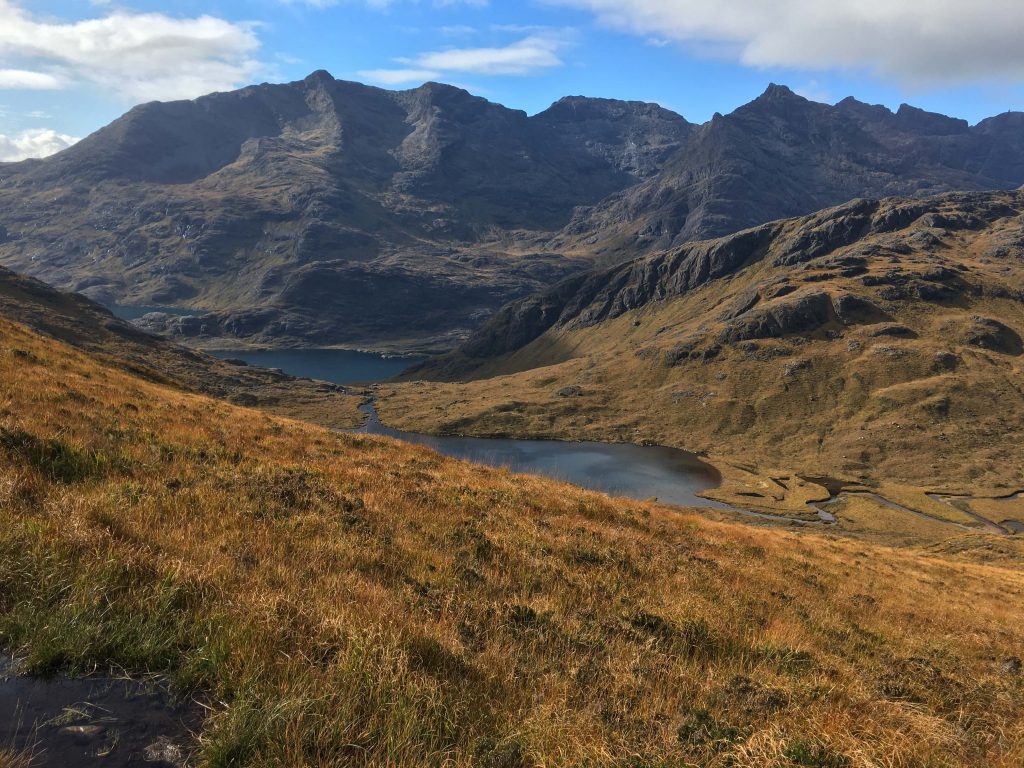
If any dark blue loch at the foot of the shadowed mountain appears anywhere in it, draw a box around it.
[210,349,423,384]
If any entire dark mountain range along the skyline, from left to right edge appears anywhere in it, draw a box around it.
[0,72,1024,350]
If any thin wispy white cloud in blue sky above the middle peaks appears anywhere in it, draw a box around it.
[358,34,566,85]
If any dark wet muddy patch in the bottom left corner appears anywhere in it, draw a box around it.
[0,657,202,768]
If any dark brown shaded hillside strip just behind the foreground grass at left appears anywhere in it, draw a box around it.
[0,267,361,428]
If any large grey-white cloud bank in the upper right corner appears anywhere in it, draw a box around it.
[548,0,1024,85]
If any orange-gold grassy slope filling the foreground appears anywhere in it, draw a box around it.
[0,319,1024,767]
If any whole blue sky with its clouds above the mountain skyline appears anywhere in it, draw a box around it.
[0,0,1024,160]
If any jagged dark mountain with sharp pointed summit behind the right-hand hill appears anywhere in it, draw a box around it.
[555,85,1024,261]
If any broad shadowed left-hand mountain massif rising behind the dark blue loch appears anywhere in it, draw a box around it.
[0,72,691,348]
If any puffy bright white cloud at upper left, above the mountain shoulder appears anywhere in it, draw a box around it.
[0,0,261,100]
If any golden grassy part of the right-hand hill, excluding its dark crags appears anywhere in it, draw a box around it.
[380,194,1024,507]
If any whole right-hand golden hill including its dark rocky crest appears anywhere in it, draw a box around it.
[380,191,1024,506]
